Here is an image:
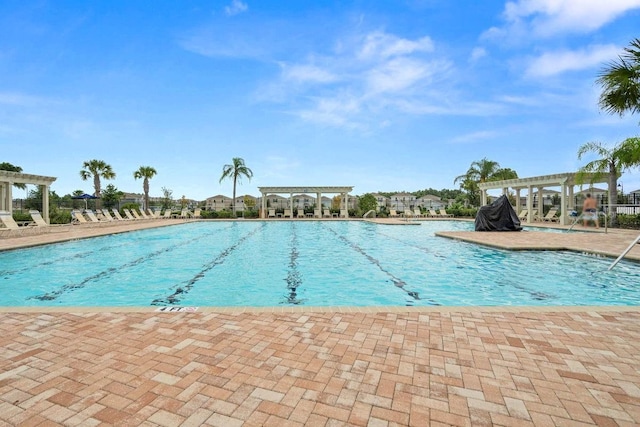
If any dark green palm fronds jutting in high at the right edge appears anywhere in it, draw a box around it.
[596,39,640,116]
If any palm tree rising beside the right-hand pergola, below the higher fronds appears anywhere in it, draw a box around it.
[578,138,640,210]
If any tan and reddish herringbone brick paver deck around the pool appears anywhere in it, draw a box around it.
[0,219,640,426]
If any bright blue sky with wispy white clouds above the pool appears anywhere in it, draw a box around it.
[0,0,640,200]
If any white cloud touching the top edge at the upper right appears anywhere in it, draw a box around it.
[484,0,640,38]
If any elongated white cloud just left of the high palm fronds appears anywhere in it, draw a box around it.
[525,45,621,77]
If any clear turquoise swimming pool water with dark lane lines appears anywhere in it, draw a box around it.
[0,221,640,307]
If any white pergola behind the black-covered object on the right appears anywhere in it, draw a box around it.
[478,173,608,225]
